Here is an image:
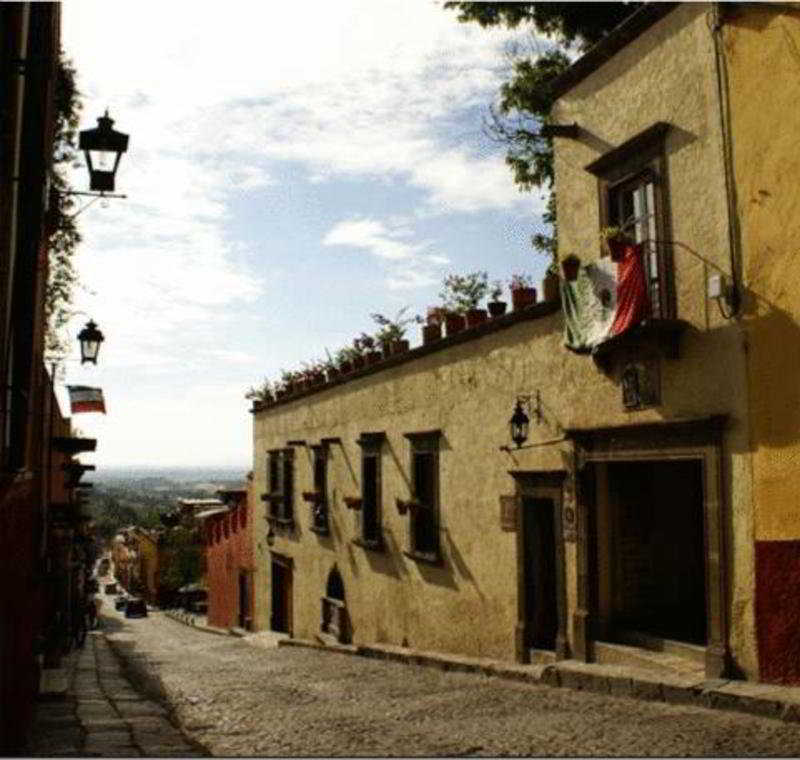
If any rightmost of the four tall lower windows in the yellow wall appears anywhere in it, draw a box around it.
[406,430,440,562]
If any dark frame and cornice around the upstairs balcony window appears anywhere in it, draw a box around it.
[585,122,676,319]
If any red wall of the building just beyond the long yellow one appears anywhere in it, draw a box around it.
[206,491,253,628]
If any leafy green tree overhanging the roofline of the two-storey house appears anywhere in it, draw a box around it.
[444,0,643,263]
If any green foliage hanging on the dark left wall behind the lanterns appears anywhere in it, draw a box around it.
[45,52,81,361]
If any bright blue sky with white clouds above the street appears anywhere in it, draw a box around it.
[58,0,547,468]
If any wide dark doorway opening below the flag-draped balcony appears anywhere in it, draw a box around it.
[596,459,707,645]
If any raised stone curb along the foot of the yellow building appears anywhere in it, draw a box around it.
[278,639,800,723]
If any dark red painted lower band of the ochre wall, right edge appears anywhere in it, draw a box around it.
[756,541,800,684]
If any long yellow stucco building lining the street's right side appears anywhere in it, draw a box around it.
[248,3,800,681]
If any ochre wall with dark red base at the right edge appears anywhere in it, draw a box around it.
[724,5,800,683]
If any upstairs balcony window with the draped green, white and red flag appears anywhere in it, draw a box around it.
[586,122,675,319]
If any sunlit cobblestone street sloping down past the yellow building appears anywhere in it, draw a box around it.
[95,611,800,756]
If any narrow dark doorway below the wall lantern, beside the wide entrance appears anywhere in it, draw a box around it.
[522,497,558,649]
